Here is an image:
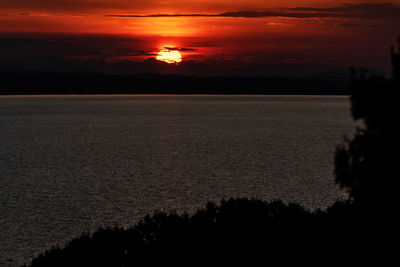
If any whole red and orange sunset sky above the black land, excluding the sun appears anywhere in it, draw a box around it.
[0,0,400,75]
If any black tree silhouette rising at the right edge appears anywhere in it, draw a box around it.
[335,39,400,223]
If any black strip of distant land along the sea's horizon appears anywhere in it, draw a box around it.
[0,72,351,95]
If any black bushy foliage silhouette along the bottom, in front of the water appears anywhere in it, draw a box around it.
[26,199,357,267]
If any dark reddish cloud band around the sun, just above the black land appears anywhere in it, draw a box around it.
[0,30,395,75]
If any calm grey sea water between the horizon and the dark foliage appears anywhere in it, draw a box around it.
[0,96,355,265]
